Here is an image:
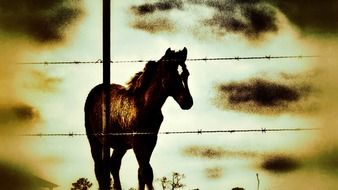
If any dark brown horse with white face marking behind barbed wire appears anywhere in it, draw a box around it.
[84,48,193,190]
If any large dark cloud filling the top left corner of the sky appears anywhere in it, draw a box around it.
[0,0,83,43]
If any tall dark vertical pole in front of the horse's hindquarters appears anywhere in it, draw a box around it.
[102,0,110,190]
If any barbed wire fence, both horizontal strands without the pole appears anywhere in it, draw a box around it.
[18,55,321,137]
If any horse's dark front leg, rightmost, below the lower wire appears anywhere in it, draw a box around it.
[133,136,157,190]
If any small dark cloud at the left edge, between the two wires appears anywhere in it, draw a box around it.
[0,104,40,125]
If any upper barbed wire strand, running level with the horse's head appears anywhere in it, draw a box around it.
[19,55,320,65]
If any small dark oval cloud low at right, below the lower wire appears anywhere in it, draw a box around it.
[261,155,301,173]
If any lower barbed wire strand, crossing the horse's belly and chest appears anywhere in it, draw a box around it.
[19,128,319,137]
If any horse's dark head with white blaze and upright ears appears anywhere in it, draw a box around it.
[160,48,193,110]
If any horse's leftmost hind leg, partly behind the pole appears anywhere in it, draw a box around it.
[88,135,111,190]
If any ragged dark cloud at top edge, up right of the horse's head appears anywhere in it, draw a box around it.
[189,0,278,39]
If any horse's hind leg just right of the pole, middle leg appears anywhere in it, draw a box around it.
[110,149,127,190]
